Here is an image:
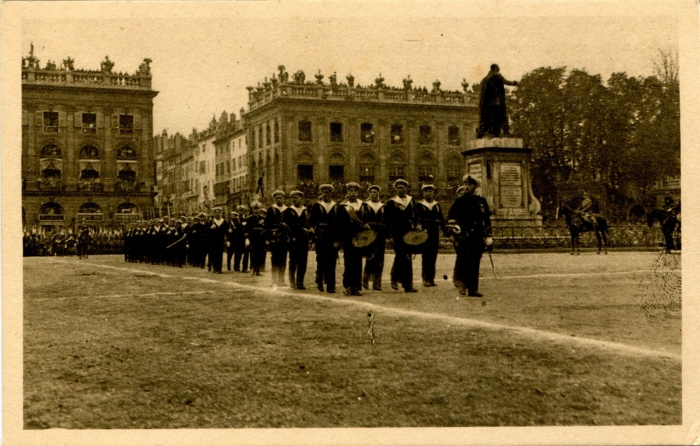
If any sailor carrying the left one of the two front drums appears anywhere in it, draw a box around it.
[335,182,369,296]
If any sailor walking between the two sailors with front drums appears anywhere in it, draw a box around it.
[362,184,386,291]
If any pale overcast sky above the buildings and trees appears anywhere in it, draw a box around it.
[22,1,679,134]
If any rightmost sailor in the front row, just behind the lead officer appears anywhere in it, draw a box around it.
[416,184,445,287]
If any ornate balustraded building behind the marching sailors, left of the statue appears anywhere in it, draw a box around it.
[245,66,478,196]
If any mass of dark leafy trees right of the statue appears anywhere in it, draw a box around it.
[508,51,680,219]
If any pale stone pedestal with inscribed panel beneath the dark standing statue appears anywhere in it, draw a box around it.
[462,138,542,227]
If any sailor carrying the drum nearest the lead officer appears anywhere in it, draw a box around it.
[384,179,422,293]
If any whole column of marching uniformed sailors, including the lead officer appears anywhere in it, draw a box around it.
[124,175,492,297]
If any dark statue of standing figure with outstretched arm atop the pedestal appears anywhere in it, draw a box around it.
[476,64,518,138]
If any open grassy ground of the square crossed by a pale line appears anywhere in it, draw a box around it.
[24,252,681,429]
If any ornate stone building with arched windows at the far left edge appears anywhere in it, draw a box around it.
[22,46,158,233]
